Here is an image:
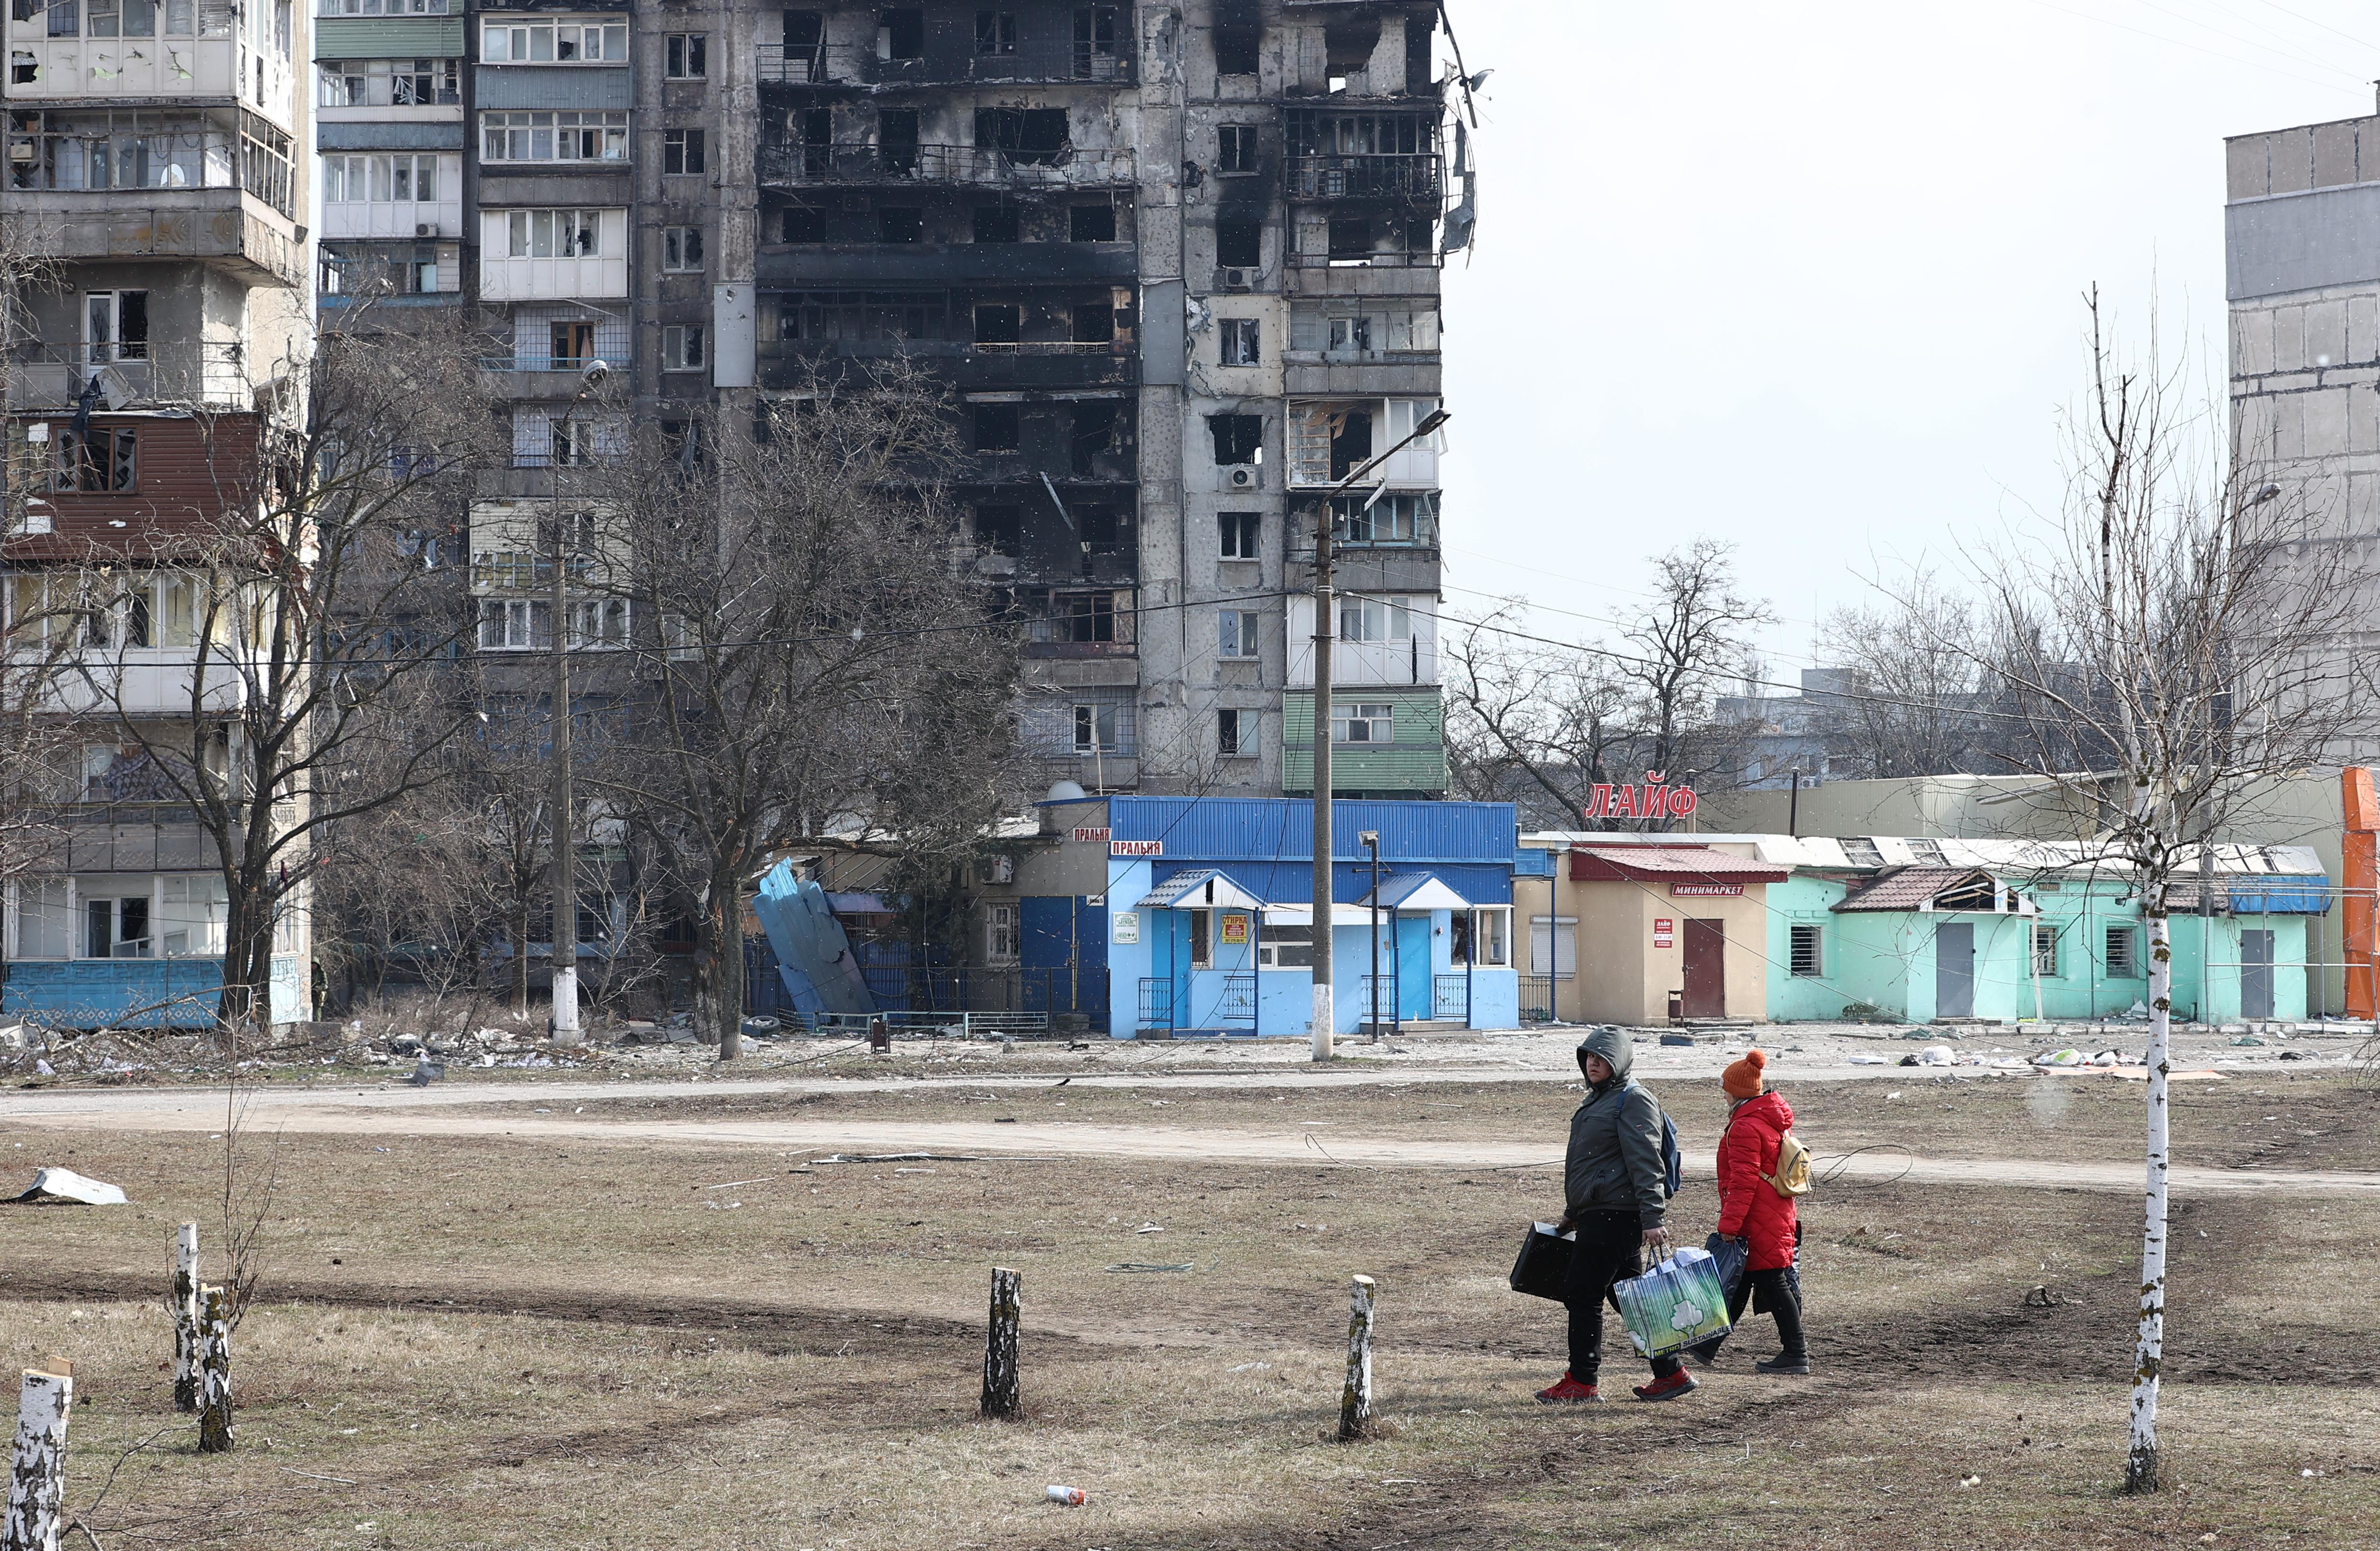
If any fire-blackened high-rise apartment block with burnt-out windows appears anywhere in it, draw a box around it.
[312,0,1468,813]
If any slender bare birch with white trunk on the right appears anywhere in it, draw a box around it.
[1902,293,2375,1491]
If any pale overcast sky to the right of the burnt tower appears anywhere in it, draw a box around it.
[1445,0,2380,680]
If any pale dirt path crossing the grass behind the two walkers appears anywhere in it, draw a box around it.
[0,1085,2380,1194]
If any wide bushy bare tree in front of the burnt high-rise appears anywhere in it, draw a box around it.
[588,361,1016,1056]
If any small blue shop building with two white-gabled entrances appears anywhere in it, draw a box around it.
[1023,797,1521,1040]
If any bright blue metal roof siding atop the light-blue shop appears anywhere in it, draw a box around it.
[1107,797,1521,873]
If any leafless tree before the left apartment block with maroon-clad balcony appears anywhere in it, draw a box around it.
[67,307,495,1030]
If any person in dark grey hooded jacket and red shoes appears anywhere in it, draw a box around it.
[1537,1028,1695,1403]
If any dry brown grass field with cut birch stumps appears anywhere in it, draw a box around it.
[0,1073,2380,1551]
